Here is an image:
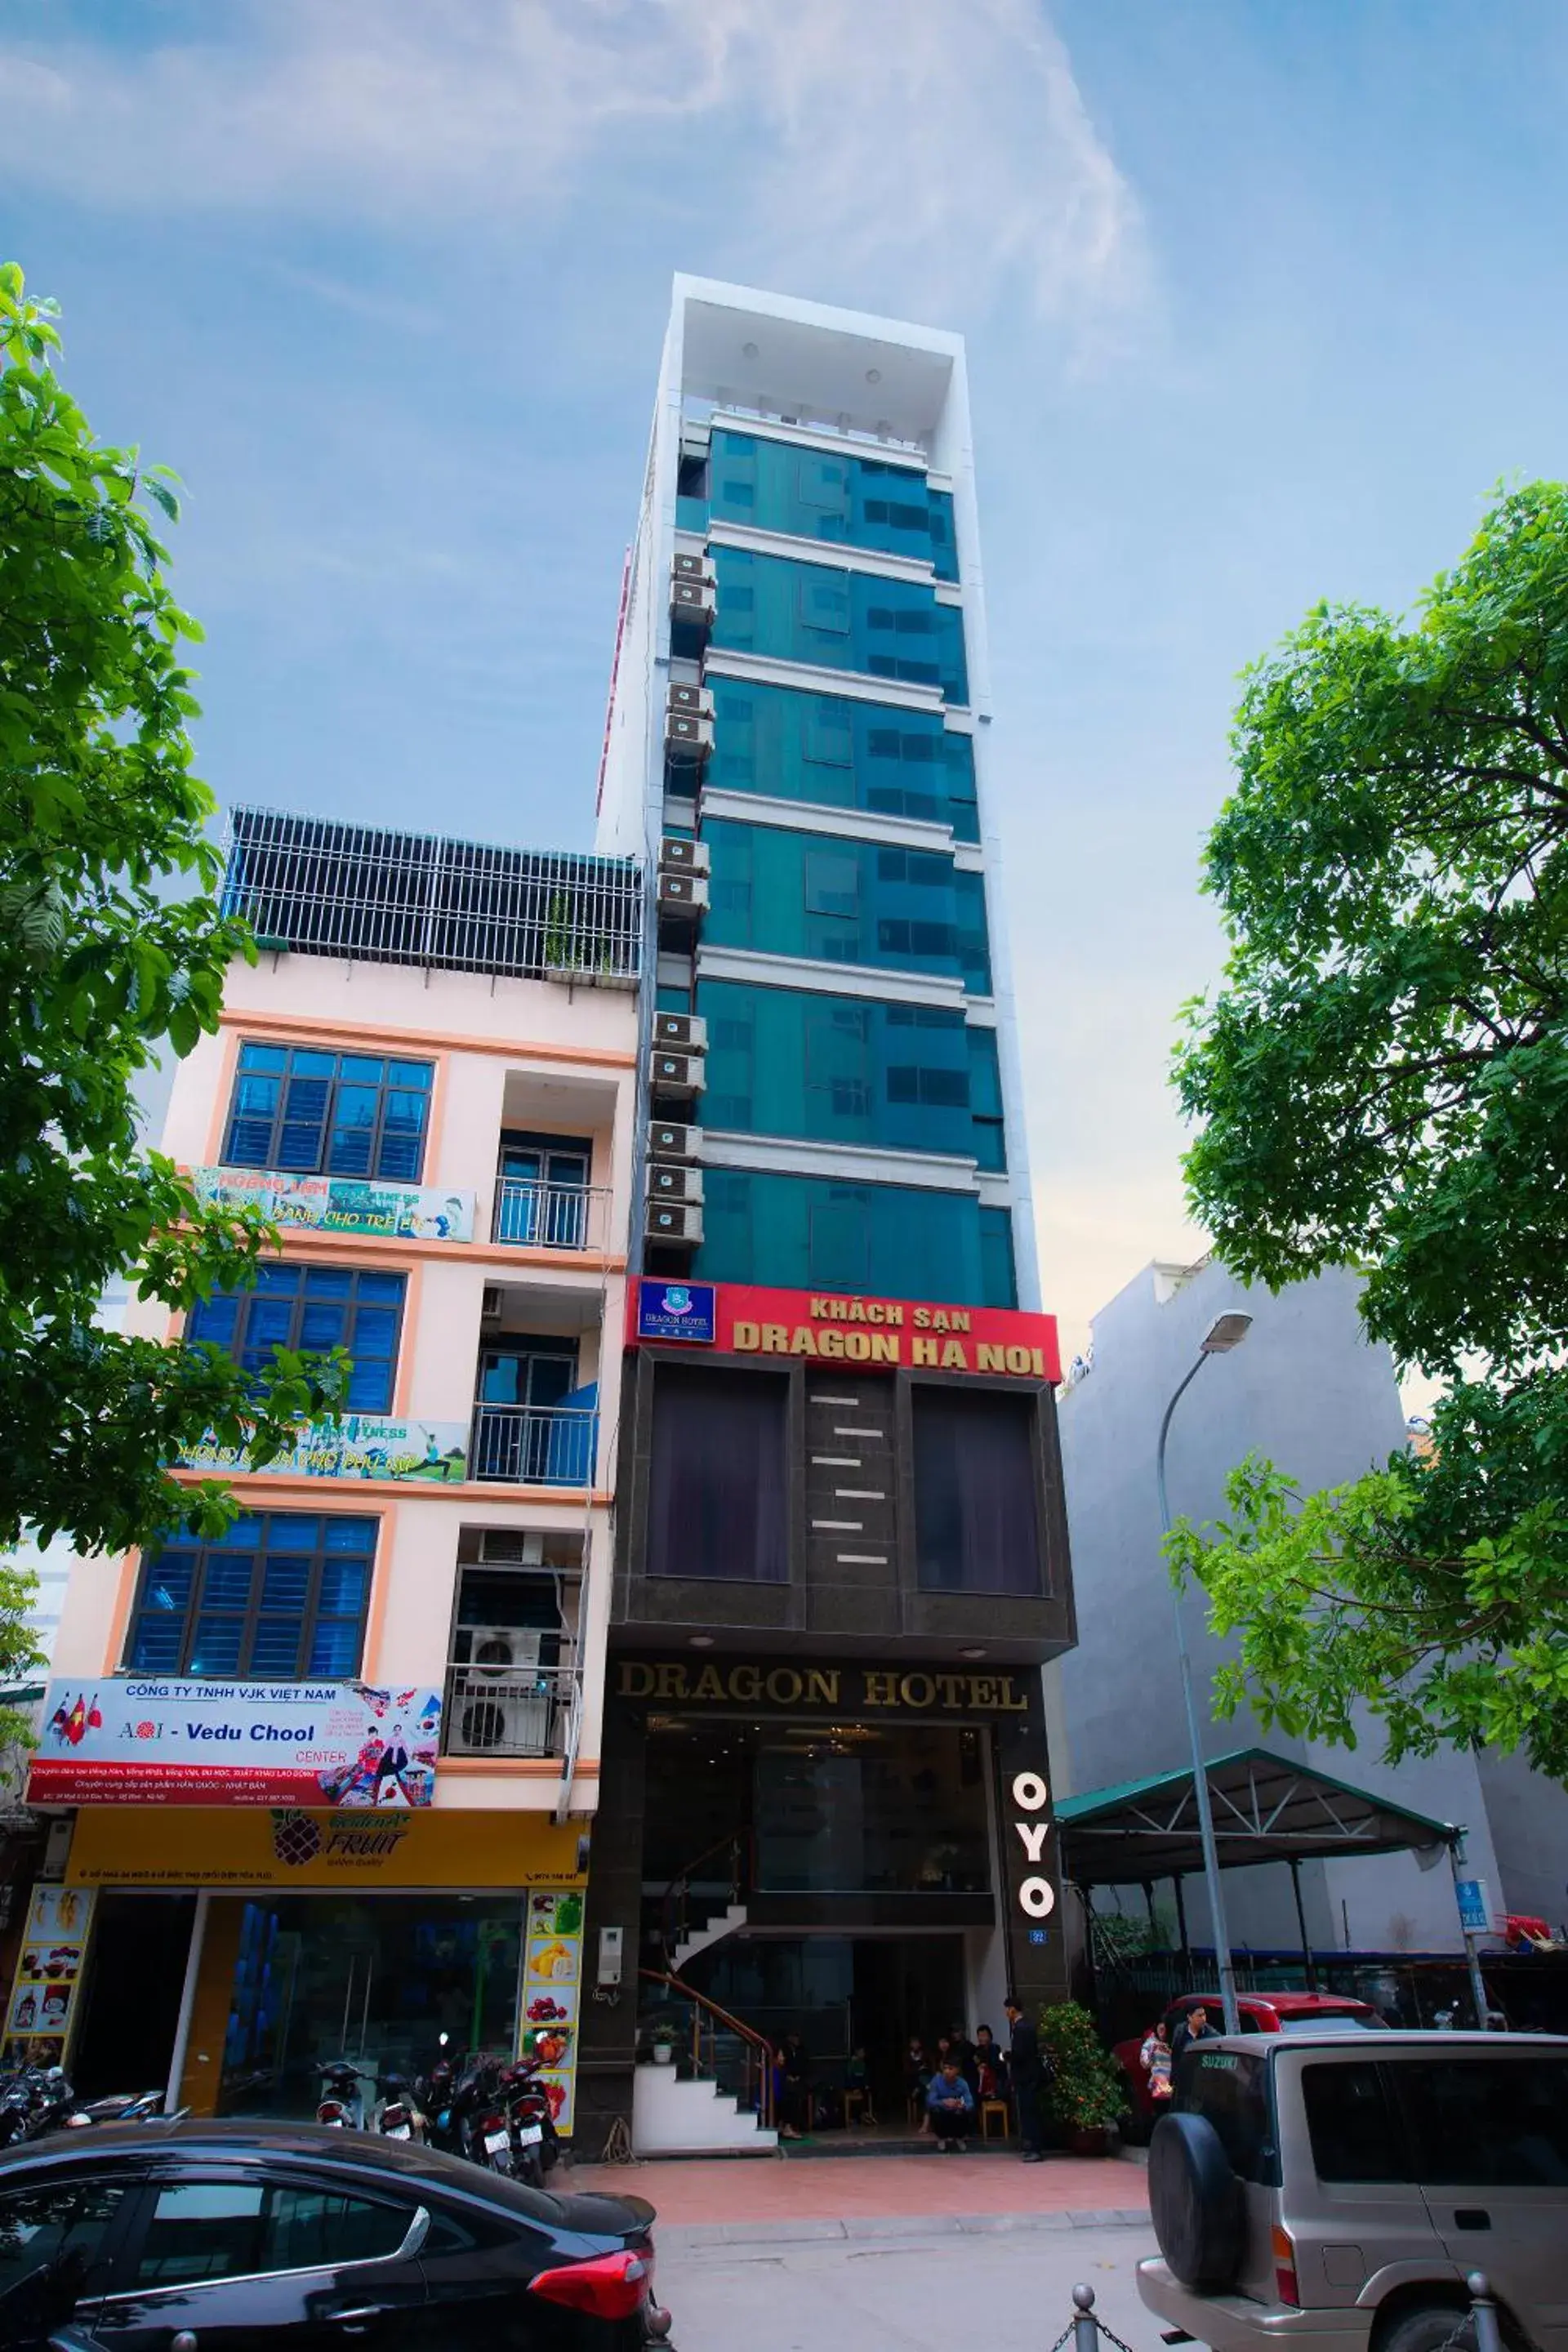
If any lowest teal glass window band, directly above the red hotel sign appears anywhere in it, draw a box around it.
[691,1169,1018,1307]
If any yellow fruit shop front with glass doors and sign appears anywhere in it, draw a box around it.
[66,1806,588,2136]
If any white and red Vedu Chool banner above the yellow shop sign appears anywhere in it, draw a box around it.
[29,1677,442,1811]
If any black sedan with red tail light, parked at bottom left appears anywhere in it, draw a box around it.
[0,2122,670,2352]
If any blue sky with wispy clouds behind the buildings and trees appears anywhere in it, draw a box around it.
[0,0,1568,1350]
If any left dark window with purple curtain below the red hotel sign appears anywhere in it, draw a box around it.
[648,1364,790,1585]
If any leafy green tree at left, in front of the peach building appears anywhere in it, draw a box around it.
[0,265,343,1570]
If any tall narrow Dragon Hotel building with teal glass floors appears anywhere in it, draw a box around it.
[578,278,1072,2149]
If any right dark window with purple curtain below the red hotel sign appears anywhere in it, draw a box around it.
[915,1388,1041,1592]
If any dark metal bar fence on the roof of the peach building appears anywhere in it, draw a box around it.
[223,809,642,988]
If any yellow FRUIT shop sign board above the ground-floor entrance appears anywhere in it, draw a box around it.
[66,1804,588,1891]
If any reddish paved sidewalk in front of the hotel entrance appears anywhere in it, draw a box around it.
[562,2157,1150,2246]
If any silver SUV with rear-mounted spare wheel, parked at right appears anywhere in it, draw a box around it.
[1138,2032,1568,2352]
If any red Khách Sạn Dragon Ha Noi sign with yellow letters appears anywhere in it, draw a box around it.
[626,1275,1062,1381]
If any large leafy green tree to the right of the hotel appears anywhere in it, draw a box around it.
[1171,482,1568,1778]
